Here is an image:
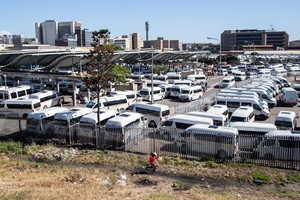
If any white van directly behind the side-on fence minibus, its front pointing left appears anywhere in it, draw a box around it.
[159,114,213,140]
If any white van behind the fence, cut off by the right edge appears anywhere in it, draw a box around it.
[255,130,300,162]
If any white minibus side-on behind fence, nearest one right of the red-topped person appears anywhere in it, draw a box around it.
[176,124,238,159]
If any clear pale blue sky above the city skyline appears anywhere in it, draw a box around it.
[0,0,300,43]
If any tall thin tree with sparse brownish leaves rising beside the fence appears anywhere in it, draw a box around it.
[84,29,115,125]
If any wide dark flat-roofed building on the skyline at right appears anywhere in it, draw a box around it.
[221,29,289,51]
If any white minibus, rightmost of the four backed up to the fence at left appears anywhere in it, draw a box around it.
[104,112,147,147]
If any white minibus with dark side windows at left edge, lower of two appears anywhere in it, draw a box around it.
[0,98,41,119]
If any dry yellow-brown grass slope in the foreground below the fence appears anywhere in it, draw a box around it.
[0,144,300,200]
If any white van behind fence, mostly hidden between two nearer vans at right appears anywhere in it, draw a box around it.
[230,122,277,154]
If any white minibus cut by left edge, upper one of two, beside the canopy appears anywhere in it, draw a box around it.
[0,85,33,103]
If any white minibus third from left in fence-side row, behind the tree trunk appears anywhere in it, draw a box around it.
[78,109,119,143]
